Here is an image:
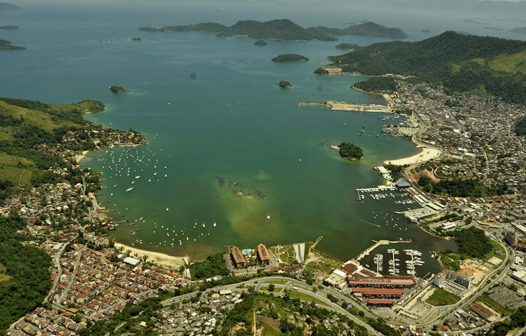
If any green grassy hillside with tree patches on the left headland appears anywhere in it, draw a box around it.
[0,98,104,194]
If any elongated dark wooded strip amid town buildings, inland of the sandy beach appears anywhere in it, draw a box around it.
[418,176,508,197]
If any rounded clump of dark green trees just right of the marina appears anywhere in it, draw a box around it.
[454,227,493,260]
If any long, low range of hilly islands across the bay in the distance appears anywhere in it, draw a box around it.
[139,19,407,41]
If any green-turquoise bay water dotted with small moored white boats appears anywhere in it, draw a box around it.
[2,1,458,272]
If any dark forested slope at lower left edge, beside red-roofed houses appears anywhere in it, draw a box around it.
[0,215,51,334]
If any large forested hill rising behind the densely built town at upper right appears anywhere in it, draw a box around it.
[330,31,526,103]
